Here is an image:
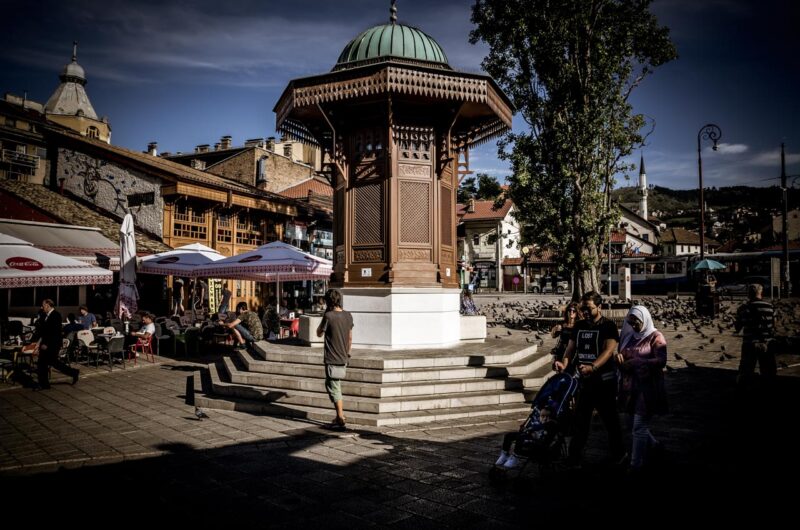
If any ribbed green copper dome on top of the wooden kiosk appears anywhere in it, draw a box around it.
[333,24,450,71]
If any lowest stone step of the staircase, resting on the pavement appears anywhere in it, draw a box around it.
[195,394,530,427]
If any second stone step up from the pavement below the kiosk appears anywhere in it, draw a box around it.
[208,364,526,414]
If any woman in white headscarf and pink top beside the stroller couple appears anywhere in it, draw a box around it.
[617,305,667,472]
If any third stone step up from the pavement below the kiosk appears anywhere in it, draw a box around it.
[223,358,522,398]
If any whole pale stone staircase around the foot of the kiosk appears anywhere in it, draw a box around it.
[195,340,550,426]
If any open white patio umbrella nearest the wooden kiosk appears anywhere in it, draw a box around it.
[197,241,333,310]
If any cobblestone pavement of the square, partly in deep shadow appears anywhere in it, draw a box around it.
[0,294,800,529]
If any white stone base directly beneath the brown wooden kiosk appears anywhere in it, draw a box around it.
[341,287,466,349]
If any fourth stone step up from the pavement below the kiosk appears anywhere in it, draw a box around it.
[236,350,550,383]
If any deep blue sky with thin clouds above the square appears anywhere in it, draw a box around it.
[0,0,800,189]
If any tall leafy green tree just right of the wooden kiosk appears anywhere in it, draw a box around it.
[470,0,676,297]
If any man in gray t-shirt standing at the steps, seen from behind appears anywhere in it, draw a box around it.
[317,289,353,430]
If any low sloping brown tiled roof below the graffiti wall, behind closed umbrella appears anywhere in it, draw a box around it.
[0,179,171,254]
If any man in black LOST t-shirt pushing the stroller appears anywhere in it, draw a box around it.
[556,291,627,466]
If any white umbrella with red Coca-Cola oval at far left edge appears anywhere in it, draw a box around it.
[0,234,114,289]
